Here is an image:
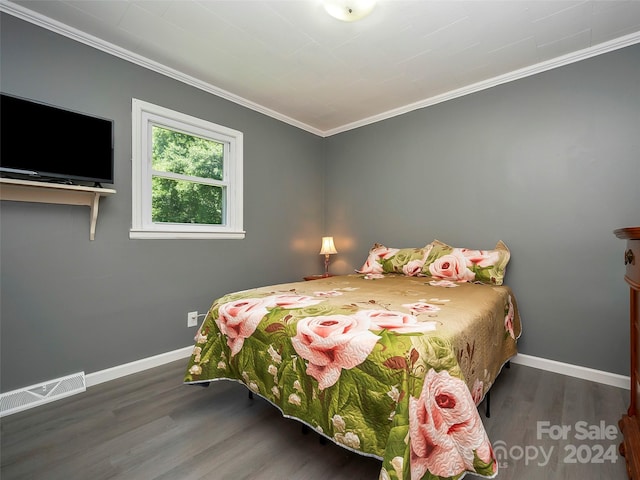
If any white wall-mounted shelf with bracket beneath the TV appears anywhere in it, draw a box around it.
[0,178,116,240]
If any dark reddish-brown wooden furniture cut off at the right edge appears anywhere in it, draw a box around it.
[614,227,640,480]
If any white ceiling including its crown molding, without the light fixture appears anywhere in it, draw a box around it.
[2,0,640,136]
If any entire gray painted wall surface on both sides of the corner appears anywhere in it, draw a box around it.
[0,15,640,391]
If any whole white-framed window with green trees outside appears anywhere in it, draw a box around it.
[129,98,244,238]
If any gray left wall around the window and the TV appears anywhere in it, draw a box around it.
[0,14,324,391]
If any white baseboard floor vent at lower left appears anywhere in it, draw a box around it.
[0,372,87,417]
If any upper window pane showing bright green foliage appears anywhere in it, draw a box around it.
[151,126,224,180]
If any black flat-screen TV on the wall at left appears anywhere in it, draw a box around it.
[0,93,113,185]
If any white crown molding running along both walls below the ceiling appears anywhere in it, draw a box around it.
[0,0,640,138]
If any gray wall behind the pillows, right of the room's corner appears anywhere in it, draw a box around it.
[325,45,640,375]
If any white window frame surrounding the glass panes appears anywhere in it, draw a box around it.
[129,98,245,239]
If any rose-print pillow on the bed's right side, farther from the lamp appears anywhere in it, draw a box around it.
[421,240,511,285]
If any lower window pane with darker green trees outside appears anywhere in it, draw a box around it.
[151,177,224,225]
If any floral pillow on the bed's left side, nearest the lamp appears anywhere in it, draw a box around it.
[356,243,431,277]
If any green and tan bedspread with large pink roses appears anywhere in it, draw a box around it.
[185,274,521,480]
